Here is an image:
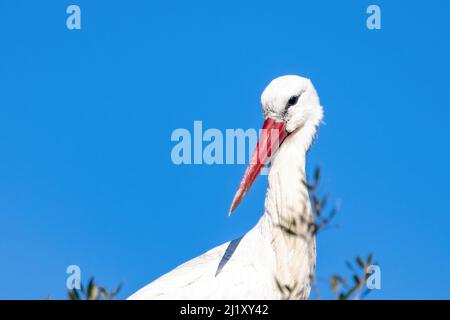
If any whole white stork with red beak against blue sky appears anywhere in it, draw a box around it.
[128,75,323,300]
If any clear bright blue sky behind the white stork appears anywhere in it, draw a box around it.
[0,0,450,299]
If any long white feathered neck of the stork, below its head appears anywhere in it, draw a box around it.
[259,124,316,299]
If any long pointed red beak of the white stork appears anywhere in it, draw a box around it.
[228,118,288,216]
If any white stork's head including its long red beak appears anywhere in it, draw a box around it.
[228,75,323,215]
